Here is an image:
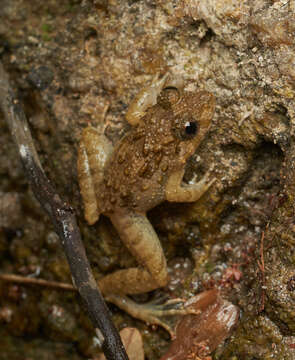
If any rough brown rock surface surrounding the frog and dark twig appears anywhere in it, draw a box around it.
[0,0,295,360]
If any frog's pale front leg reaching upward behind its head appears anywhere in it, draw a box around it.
[125,74,168,126]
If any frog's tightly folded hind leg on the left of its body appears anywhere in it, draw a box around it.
[77,127,113,225]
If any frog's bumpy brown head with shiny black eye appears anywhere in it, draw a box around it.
[158,88,215,163]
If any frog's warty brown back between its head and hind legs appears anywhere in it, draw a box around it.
[97,105,177,214]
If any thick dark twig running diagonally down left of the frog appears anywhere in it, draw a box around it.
[0,63,128,360]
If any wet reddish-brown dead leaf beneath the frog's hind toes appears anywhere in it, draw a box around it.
[161,289,239,360]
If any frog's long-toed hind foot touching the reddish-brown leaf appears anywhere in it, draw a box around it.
[105,295,197,339]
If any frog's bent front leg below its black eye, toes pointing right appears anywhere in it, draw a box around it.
[165,169,216,202]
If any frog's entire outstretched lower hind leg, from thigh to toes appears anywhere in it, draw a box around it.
[98,213,192,336]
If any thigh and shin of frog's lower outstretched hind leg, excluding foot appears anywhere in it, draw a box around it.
[99,214,168,294]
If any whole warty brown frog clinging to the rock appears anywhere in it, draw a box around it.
[77,74,216,336]
